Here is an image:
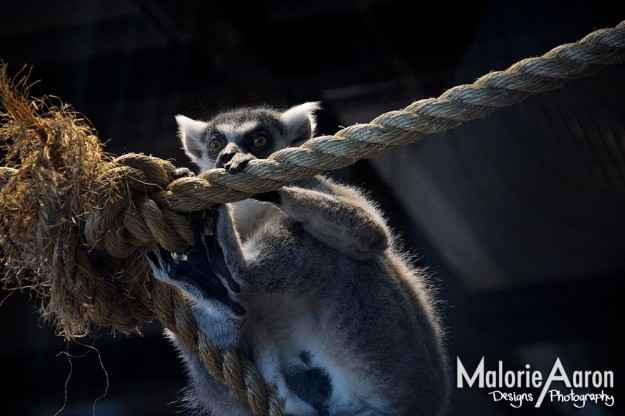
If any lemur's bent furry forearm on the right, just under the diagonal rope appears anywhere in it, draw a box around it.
[255,177,390,260]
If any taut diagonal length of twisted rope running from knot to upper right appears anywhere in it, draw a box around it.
[160,21,625,219]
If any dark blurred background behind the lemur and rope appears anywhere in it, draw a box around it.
[0,0,625,416]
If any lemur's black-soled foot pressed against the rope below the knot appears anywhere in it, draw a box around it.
[147,213,246,317]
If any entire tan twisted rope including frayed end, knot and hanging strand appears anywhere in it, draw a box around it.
[0,22,625,416]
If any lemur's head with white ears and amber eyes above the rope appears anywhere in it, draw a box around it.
[176,102,319,171]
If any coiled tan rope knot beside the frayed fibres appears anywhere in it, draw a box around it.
[84,154,193,258]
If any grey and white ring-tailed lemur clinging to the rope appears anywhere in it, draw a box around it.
[148,103,448,416]
